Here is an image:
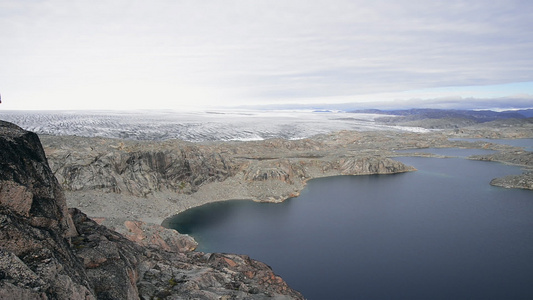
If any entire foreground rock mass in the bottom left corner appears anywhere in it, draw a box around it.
[0,121,302,299]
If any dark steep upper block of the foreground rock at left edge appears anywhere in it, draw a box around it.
[0,121,75,235]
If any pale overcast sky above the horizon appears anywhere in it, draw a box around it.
[0,0,533,110]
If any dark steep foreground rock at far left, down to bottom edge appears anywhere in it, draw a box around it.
[0,121,94,299]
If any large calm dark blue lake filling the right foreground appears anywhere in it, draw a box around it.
[163,157,533,299]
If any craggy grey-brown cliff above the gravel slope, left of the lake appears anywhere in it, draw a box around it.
[44,137,234,196]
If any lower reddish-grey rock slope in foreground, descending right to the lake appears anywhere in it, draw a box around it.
[70,209,303,299]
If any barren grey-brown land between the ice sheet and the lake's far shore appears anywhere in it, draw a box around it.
[41,119,533,231]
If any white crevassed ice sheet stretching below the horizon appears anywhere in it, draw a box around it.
[0,110,424,142]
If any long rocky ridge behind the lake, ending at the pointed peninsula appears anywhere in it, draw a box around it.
[44,134,413,201]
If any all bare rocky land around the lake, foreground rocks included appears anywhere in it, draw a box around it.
[0,113,533,299]
